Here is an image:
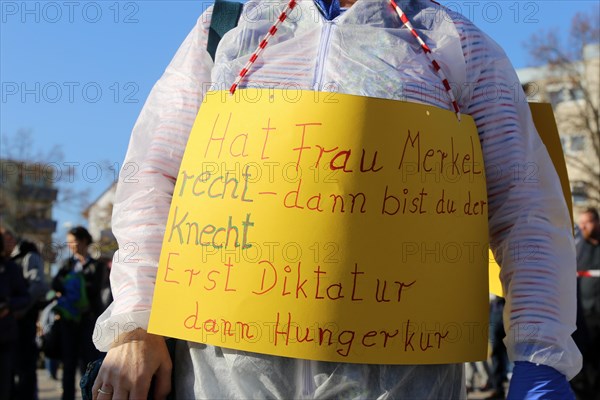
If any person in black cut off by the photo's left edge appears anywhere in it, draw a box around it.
[0,233,30,400]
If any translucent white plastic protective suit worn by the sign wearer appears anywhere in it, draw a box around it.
[95,0,581,400]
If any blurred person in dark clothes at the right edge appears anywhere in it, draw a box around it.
[572,208,600,400]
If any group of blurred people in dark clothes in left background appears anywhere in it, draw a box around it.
[0,226,109,400]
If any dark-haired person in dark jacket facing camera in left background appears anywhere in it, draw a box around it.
[52,226,106,400]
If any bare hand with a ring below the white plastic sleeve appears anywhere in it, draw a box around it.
[92,329,172,400]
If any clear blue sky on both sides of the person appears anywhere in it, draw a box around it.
[0,0,600,245]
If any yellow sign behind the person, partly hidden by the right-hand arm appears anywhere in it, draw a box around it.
[489,103,573,297]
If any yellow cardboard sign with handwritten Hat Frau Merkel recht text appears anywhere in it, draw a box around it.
[150,89,488,364]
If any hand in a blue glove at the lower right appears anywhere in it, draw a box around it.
[507,361,575,400]
